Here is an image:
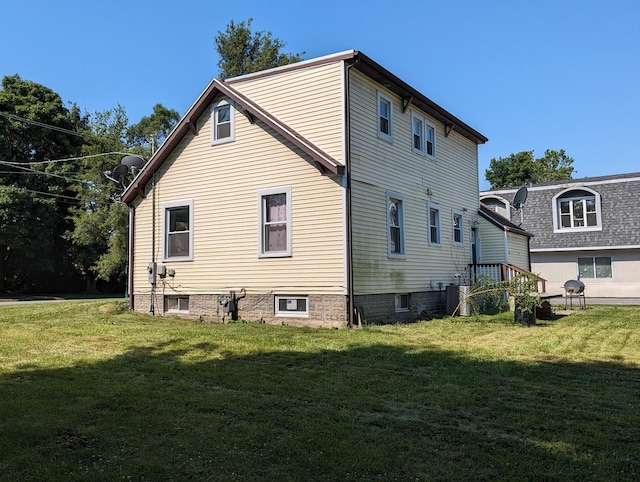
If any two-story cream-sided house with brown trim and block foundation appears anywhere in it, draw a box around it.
[123,51,487,327]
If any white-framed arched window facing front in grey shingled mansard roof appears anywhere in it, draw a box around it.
[553,187,602,232]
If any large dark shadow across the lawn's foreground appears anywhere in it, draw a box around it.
[0,340,640,481]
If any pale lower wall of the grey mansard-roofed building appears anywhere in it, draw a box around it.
[531,249,640,298]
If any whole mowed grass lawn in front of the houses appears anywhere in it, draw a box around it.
[0,300,640,481]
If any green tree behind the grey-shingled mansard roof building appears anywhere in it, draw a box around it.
[485,149,574,189]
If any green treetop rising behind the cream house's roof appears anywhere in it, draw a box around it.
[214,18,304,79]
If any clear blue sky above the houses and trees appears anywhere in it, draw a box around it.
[0,0,640,189]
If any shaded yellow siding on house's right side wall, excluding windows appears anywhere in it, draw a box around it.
[350,71,479,294]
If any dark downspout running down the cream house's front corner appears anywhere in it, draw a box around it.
[345,60,360,328]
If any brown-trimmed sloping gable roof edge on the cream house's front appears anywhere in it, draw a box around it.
[122,79,344,203]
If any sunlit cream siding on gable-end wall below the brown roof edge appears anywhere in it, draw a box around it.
[134,99,345,295]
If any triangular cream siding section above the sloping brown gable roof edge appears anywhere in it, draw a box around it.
[226,62,344,163]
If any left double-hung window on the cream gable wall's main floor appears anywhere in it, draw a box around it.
[162,199,193,261]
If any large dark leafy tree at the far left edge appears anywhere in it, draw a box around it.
[0,75,86,291]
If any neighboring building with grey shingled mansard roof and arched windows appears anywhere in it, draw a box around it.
[481,173,640,297]
